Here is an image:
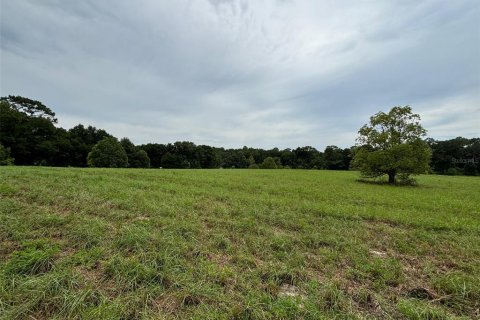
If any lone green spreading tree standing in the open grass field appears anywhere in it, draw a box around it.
[353,106,431,184]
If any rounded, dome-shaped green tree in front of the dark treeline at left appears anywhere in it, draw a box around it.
[87,138,128,168]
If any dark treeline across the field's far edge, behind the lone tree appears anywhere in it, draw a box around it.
[0,96,480,175]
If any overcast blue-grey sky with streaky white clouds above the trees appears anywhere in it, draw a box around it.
[0,0,480,150]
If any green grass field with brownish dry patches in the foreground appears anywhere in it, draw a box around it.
[0,167,480,319]
